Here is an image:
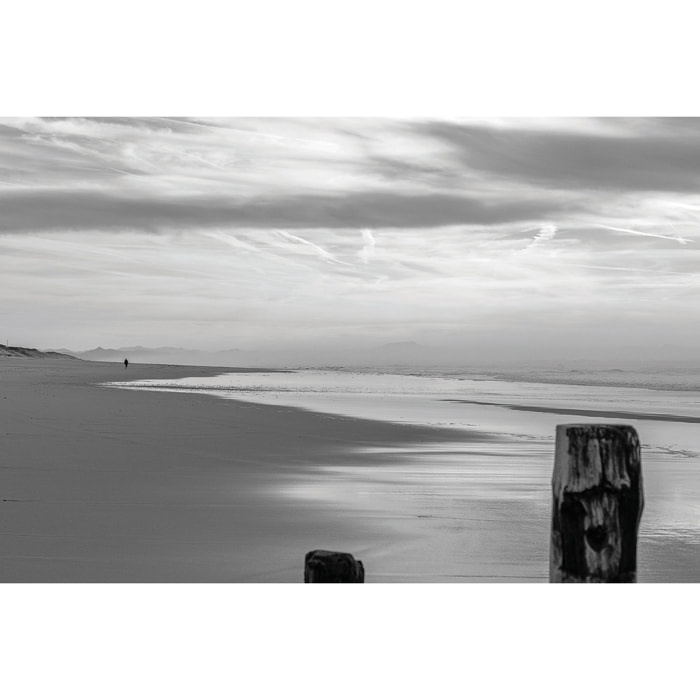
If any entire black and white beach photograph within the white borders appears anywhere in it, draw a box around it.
[5,117,700,583]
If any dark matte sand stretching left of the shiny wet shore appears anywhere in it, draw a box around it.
[0,358,482,582]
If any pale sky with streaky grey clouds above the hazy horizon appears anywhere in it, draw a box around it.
[0,118,700,362]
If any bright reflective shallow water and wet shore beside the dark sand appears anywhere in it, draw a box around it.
[105,367,700,583]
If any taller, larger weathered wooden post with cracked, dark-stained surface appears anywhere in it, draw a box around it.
[549,424,644,583]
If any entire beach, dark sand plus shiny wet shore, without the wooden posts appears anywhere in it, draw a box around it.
[0,358,700,583]
